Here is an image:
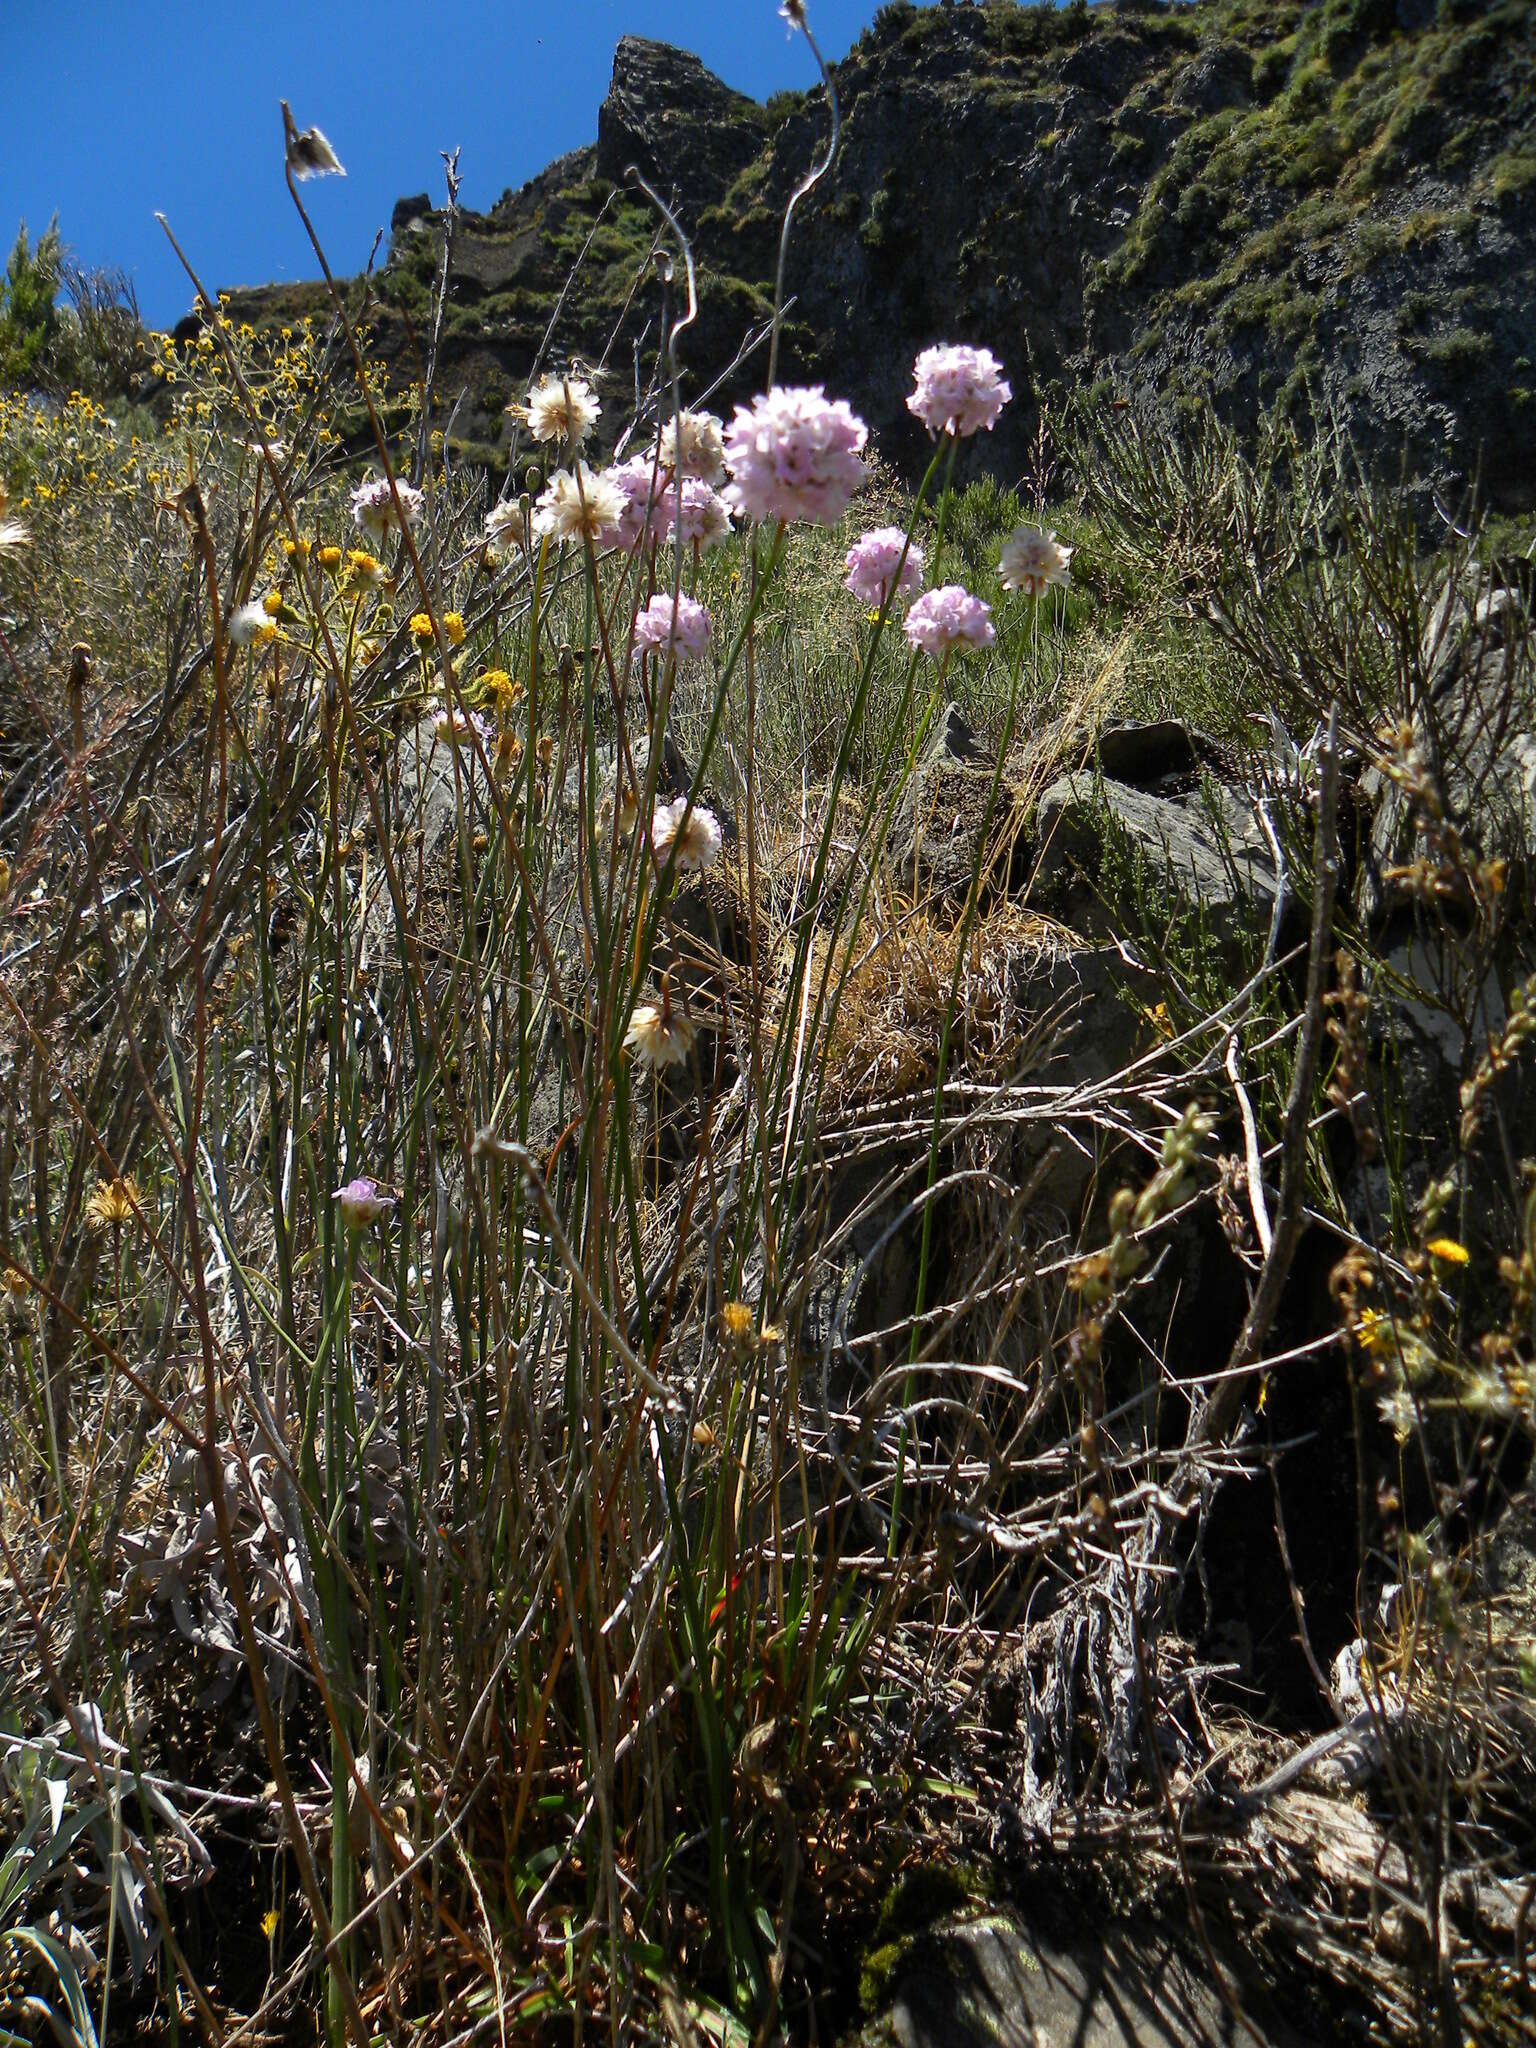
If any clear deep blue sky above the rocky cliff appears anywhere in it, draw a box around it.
[0,0,877,326]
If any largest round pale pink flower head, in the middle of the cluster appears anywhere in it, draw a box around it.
[725,385,868,526]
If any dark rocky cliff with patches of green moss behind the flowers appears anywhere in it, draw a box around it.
[214,0,1536,512]
